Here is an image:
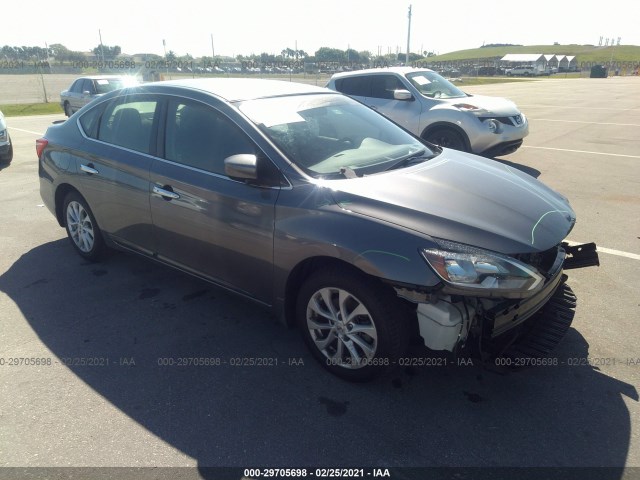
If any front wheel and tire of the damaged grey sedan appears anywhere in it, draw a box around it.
[296,267,410,382]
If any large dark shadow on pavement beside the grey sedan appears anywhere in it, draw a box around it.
[0,240,638,480]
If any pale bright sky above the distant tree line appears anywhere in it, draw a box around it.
[0,0,640,57]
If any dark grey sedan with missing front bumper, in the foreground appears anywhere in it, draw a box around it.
[36,78,598,380]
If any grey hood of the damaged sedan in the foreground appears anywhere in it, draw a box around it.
[328,149,575,254]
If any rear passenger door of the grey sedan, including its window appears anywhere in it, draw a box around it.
[76,91,161,253]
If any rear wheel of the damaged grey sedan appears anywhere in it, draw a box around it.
[62,192,106,262]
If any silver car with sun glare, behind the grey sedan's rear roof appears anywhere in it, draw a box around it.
[60,75,138,117]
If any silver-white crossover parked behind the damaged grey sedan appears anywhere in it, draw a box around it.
[327,67,529,157]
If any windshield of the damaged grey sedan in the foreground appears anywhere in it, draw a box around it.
[240,94,433,178]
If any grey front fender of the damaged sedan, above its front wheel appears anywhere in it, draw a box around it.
[274,185,439,308]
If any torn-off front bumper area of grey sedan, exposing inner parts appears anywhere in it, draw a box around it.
[396,243,600,359]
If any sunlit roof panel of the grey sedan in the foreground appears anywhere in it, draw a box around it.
[149,78,336,102]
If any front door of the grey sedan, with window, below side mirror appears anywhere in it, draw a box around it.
[150,97,279,303]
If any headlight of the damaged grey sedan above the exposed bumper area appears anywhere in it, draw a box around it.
[422,240,544,296]
